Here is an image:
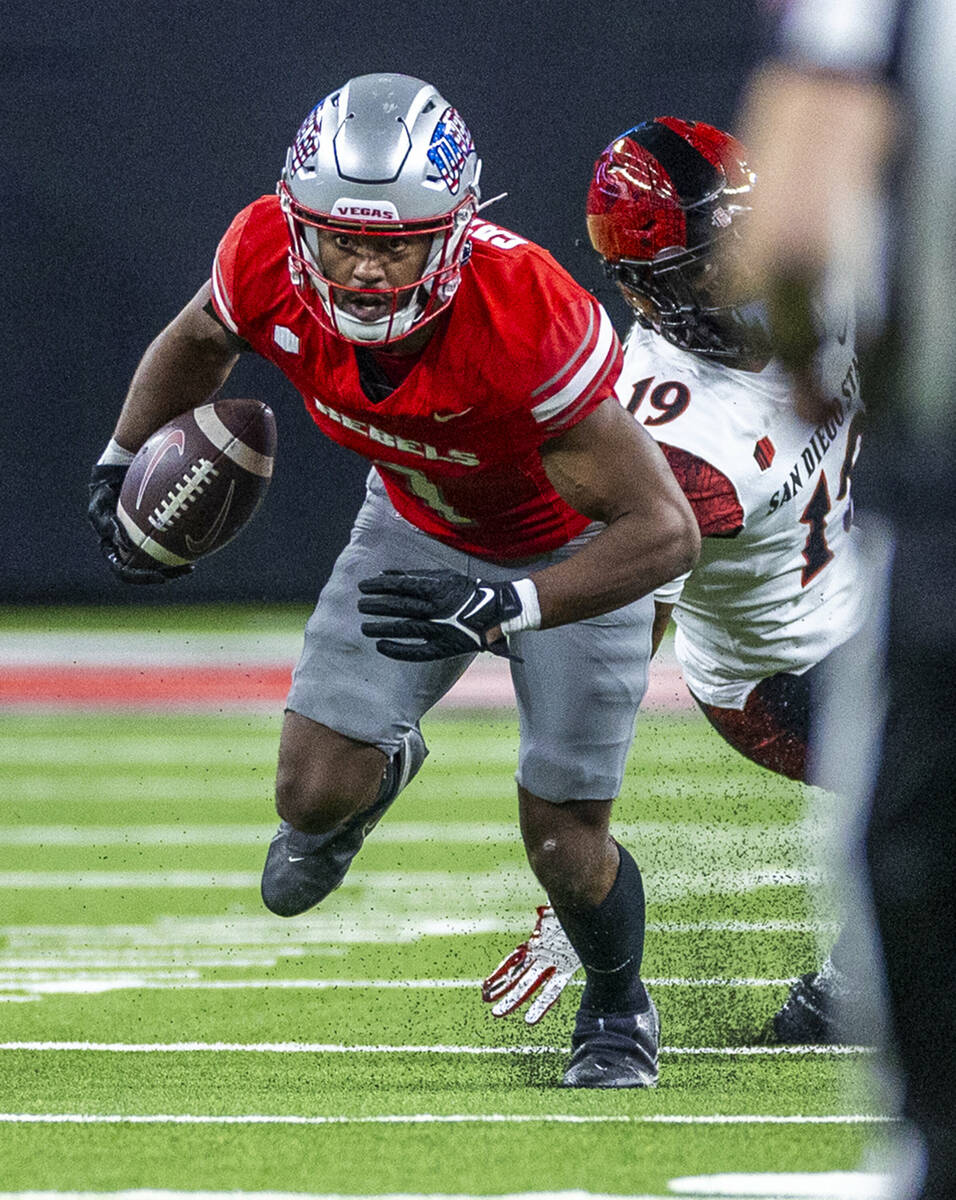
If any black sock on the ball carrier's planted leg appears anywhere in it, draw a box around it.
[553,845,650,1013]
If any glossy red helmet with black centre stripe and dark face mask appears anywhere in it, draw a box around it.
[588,116,769,365]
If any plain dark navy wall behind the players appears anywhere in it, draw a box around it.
[0,0,760,604]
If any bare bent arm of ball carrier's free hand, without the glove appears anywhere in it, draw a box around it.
[531,398,701,629]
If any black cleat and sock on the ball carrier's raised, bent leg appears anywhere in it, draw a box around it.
[260,730,428,917]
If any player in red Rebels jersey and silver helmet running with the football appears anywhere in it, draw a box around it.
[90,74,699,1087]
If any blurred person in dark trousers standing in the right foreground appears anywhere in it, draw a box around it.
[745,0,956,1200]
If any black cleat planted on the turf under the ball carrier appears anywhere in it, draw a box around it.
[561,1001,661,1087]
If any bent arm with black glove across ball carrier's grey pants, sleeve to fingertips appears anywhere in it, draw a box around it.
[359,398,701,661]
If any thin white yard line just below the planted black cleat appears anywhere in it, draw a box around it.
[0,1112,896,1126]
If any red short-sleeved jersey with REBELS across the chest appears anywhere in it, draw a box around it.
[212,196,621,560]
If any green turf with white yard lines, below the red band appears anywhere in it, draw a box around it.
[0,643,882,1195]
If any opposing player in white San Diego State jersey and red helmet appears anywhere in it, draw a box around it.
[485,118,864,1042]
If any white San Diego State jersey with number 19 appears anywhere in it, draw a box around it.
[618,326,864,708]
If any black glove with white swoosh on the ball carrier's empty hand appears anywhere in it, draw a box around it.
[359,571,522,662]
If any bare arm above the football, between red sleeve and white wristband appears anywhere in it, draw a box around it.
[113,283,239,451]
